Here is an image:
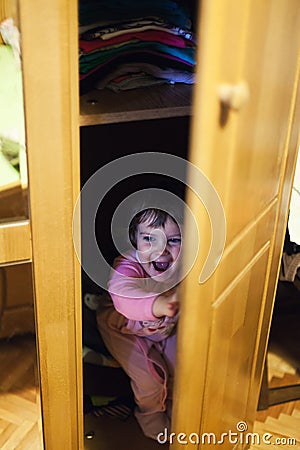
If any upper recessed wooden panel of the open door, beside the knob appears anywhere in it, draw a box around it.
[225,0,300,241]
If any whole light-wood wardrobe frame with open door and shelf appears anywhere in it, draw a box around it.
[1,0,300,450]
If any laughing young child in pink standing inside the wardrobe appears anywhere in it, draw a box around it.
[97,208,181,439]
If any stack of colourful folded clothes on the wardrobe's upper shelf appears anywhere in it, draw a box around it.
[79,0,196,93]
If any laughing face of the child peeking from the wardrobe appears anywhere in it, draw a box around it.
[136,218,181,281]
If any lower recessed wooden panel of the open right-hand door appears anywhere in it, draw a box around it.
[202,248,269,434]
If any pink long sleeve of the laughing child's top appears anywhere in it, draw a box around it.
[108,252,159,321]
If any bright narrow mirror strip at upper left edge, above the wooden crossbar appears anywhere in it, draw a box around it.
[0,18,28,223]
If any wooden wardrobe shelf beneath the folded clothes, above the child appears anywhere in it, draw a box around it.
[79,84,192,126]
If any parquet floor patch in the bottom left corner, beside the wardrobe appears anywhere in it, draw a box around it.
[0,335,43,450]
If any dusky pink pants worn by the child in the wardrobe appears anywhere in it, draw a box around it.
[97,298,176,439]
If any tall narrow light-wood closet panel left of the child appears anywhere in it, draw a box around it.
[19,0,83,450]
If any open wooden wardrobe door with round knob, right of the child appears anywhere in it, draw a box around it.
[172,0,300,449]
